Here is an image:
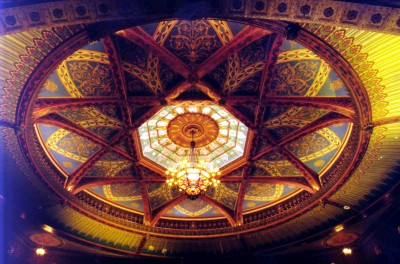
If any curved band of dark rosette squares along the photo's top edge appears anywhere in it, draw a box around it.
[0,0,400,34]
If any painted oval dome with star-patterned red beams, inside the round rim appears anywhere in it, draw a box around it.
[32,20,356,227]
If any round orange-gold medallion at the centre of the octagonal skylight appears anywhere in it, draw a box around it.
[167,113,219,148]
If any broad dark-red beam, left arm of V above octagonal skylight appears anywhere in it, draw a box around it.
[115,27,191,79]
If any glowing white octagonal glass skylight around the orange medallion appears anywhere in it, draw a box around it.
[139,104,248,168]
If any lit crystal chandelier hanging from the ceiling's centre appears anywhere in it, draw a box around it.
[165,126,221,200]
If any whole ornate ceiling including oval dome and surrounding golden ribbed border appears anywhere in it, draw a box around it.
[0,1,400,257]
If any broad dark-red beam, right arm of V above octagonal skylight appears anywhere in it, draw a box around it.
[195,26,271,79]
